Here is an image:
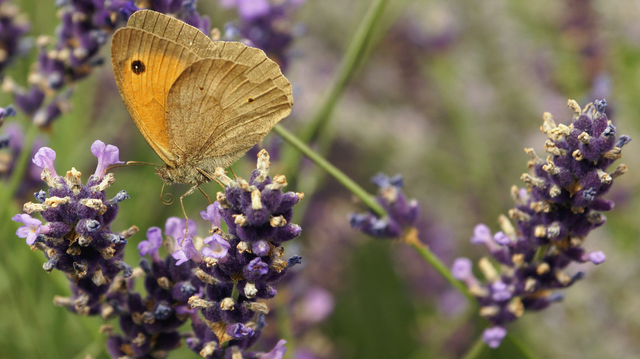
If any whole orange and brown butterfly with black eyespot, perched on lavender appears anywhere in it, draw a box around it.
[111,10,293,217]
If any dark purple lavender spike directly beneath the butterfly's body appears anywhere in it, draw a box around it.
[181,150,302,358]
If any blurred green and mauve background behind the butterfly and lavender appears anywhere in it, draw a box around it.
[0,0,640,359]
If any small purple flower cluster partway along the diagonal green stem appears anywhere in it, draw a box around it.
[349,173,420,238]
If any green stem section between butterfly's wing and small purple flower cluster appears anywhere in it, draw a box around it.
[273,125,387,217]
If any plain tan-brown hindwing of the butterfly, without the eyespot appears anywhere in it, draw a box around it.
[166,58,291,171]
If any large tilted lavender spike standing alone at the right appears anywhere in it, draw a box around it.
[452,100,631,348]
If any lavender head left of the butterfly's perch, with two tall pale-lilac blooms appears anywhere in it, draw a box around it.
[13,139,132,315]
